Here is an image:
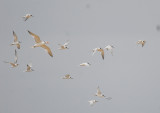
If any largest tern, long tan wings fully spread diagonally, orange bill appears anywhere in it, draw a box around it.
[28,31,53,57]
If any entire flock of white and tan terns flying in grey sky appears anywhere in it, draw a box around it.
[4,14,146,106]
